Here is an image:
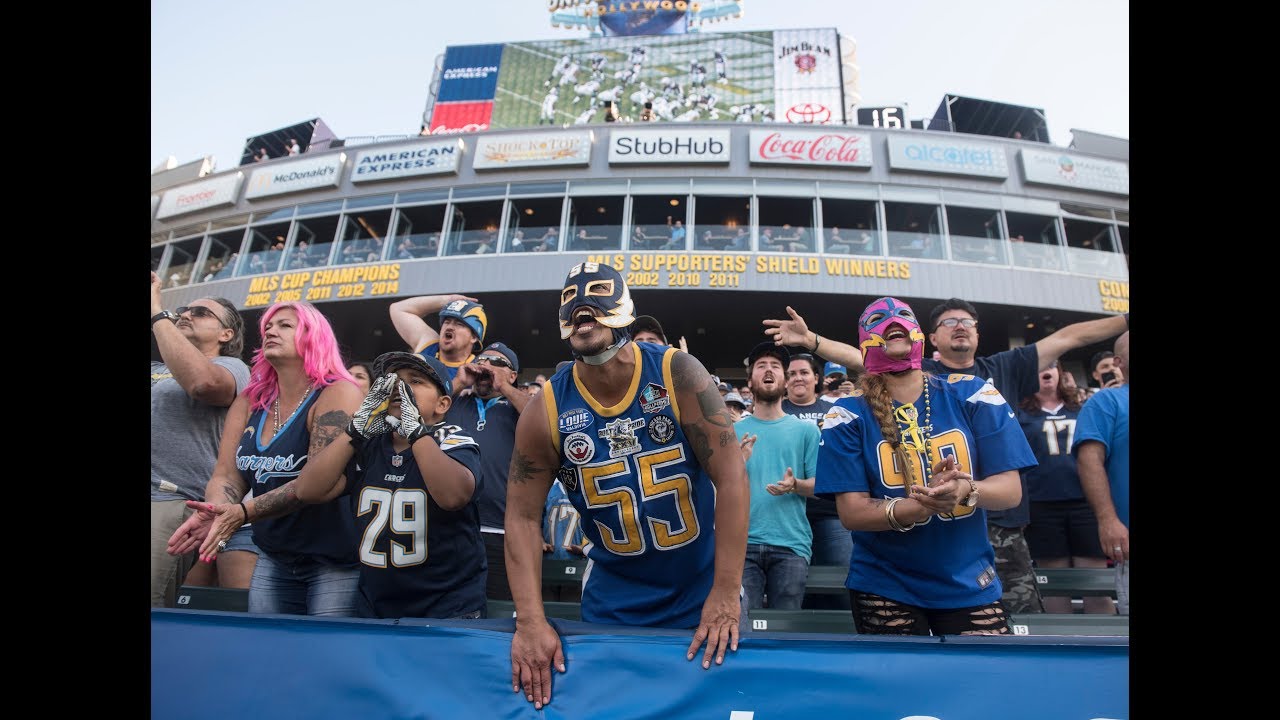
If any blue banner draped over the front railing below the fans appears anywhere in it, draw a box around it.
[151,610,1129,720]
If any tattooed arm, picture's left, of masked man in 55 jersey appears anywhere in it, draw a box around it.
[503,388,564,710]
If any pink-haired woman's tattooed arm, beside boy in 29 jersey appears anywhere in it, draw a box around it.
[244,380,365,521]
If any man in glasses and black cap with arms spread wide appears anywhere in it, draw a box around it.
[764,297,1129,615]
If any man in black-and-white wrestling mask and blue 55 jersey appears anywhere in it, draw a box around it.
[507,263,749,710]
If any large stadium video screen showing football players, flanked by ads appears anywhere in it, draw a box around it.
[430,28,845,135]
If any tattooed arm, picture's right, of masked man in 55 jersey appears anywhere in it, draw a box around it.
[671,352,751,667]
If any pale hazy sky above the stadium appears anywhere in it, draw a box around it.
[151,0,1129,170]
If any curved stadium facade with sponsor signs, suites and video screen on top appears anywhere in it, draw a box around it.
[151,29,1129,379]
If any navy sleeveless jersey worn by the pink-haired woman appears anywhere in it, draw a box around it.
[236,388,356,565]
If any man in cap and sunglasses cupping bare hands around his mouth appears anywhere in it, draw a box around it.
[444,342,531,600]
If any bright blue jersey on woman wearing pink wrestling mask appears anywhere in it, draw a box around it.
[814,374,1036,609]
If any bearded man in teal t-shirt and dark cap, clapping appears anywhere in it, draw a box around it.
[733,341,819,610]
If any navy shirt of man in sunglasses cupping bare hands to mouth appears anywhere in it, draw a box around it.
[444,395,520,529]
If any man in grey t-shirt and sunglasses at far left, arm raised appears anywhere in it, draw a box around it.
[151,272,250,607]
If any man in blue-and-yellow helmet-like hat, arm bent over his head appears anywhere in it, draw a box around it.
[390,295,489,382]
